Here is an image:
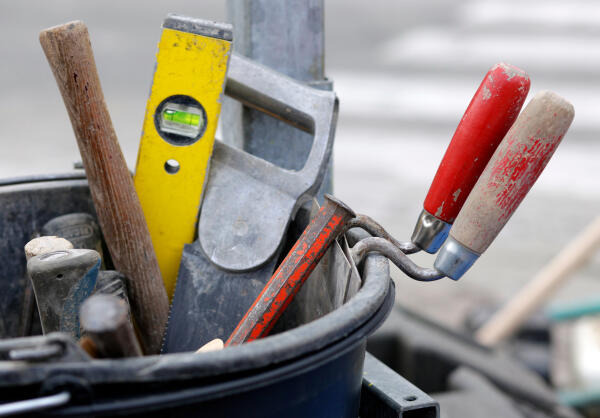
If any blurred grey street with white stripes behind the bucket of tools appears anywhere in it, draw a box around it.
[0,0,600,324]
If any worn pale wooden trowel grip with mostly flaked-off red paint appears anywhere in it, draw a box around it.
[450,91,574,254]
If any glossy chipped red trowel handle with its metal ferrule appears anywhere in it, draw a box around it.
[412,63,530,254]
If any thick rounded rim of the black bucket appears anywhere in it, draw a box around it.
[0,173,391,387]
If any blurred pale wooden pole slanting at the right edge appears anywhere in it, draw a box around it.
[475,217,600,346]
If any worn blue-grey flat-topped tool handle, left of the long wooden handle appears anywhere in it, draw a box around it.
[27,249,100,339]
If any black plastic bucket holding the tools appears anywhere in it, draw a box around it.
[0,175,394,418]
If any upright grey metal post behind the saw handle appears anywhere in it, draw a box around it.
[221,0,332,200]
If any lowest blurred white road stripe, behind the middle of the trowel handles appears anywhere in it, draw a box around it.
[334,125,600,200]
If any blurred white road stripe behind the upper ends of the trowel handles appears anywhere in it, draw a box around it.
[330,70,600,134]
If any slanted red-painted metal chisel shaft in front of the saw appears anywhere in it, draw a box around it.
[225,195,355,346]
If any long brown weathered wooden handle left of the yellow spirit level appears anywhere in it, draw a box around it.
[40,21,169,354]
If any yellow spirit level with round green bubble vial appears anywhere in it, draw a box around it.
[134,15,232,298]
